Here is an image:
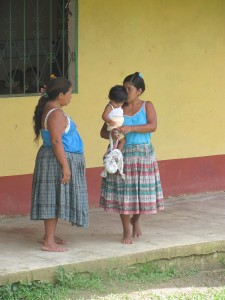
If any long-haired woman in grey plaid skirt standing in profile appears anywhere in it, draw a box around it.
[31,77,88,252]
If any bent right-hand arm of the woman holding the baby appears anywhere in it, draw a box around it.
[119,101,157,134]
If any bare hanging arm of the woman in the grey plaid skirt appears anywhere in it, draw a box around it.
[48,110,71,183]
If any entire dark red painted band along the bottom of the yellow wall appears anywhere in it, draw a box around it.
[0,155,225,215]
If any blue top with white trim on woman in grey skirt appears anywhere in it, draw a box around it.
[41,109,84,153]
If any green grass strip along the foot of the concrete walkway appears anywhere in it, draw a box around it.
[0,263,225,300]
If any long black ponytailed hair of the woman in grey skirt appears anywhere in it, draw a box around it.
[33,77,72,141]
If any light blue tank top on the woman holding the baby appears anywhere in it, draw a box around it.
[123,102,152,145]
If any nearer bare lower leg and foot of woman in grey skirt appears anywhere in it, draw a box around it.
[41,218,69,252]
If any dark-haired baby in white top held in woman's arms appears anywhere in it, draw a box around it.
[102,85,128,151]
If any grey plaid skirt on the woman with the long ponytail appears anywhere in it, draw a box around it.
[30,146,88,227]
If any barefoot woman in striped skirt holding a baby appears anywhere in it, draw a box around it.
[100,72,164,244]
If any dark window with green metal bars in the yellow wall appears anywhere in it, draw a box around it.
[0,0,77,95]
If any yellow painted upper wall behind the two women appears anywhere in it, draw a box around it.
[0,0,225,176]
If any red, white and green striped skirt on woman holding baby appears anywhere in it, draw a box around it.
[100,144,164,214]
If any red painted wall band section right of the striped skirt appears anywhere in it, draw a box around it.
[159,155,225,197]
